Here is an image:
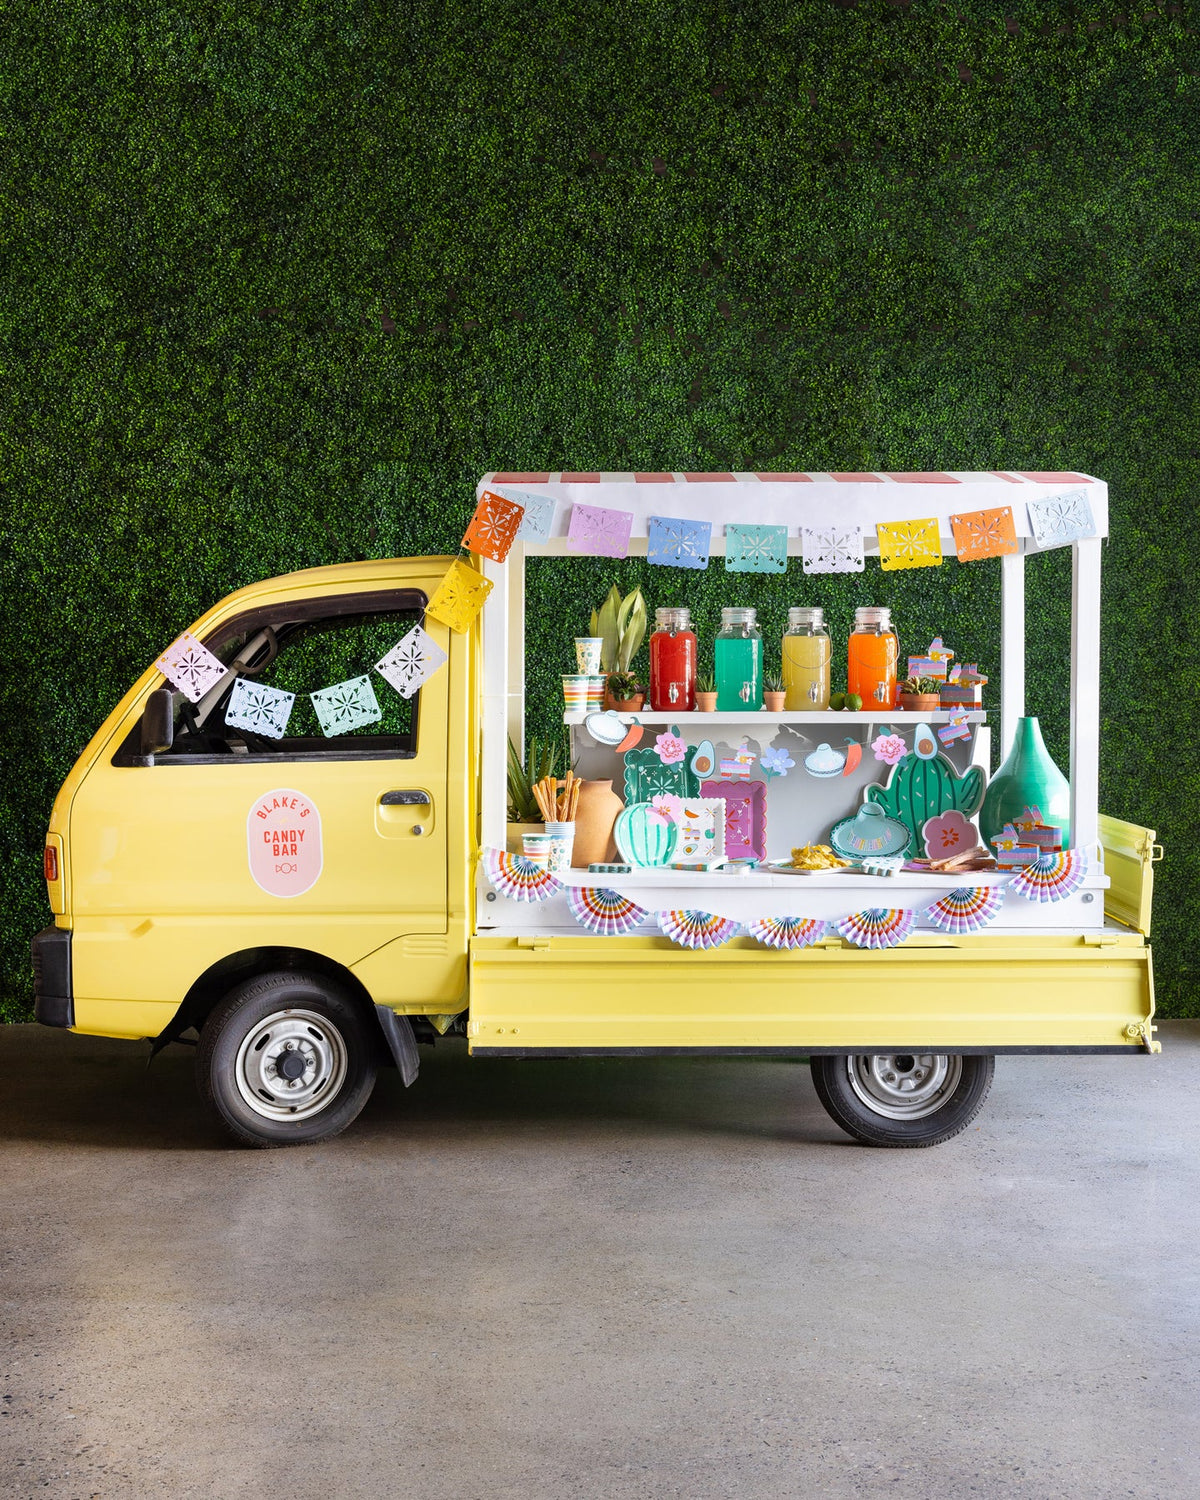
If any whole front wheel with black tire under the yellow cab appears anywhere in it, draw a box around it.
[197,972,378,1146]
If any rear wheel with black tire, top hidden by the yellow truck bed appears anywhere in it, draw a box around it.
[809,1052,996,1146]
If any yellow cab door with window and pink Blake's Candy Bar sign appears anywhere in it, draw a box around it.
[71,588,453,1034]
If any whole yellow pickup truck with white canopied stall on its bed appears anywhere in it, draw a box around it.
[33,473,1160,1146]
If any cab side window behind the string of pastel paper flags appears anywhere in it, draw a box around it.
[117,591,425,764]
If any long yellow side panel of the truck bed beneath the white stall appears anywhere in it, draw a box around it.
[468,930,1154,1053]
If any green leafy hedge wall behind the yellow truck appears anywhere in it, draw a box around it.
[0,0,1200,1019]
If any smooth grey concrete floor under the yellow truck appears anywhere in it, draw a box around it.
[0,1022,1200,1500]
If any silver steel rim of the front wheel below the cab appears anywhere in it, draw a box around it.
[234,1011,348,1121]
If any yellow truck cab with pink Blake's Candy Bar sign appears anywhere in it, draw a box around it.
[35,558,479,1140]
